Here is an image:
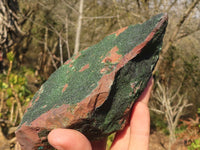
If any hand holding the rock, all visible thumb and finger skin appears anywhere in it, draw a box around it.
[48,78,153,150]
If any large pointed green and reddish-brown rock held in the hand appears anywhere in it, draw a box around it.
[16,14,167,150]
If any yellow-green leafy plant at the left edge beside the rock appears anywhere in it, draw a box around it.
[0,68,33,125]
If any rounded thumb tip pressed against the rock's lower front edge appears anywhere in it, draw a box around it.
[48,129,92,150]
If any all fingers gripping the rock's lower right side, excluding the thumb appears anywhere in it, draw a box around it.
[111,78,153,150]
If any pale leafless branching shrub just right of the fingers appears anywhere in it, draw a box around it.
[150,82,192,149]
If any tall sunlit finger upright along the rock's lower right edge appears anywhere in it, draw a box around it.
[129,78,153,150]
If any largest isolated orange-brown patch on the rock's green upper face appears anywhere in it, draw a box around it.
[102,46,122,64]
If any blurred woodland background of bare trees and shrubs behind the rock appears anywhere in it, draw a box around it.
[0,0,200,150]
